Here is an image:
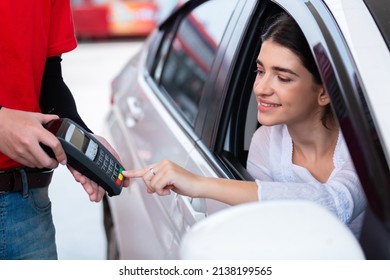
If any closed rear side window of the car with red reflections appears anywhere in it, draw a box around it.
[154,0,238,125]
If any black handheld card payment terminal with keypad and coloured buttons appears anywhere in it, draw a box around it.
[43,118,124,196]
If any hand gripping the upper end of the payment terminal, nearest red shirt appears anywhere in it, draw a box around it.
[0,107,66,168]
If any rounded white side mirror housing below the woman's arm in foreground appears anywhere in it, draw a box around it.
[180,201,365,260]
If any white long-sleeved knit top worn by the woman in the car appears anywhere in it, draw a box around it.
[247,125,366,235]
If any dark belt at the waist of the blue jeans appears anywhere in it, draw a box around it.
[0,168,53,192]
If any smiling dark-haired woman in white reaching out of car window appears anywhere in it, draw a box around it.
[124,13,365,234]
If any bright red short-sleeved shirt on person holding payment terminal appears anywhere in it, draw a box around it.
[0,0,77,170]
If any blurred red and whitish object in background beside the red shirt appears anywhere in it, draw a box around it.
[72,0,158,38]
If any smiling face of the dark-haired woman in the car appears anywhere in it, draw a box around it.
[253,40,323,126]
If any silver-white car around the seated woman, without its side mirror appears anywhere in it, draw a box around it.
[104,0,390,259]
